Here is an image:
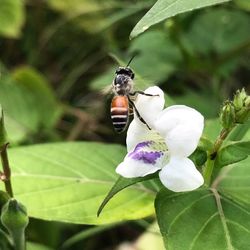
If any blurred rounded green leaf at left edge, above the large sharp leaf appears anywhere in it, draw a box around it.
[0,67,61,143]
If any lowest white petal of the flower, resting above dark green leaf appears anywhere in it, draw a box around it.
[159,157,204,192]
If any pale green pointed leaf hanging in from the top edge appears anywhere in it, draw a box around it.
[130,0,228,37]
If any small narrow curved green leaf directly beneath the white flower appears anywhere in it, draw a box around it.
[97,173,158,216]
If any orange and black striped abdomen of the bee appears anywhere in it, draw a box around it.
[111,95,129,133]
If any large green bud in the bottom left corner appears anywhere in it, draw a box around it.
[1,198,29,234]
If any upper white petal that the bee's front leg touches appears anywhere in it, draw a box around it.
[134,86,165,128]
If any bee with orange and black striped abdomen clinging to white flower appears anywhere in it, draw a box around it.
[111,56,158,133]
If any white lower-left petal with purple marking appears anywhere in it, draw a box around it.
[116,141,165,178]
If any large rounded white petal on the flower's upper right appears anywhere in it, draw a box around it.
[154,105,204,157]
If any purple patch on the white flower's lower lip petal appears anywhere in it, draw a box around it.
[128,141,163,165]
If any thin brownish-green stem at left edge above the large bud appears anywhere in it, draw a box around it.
[0,143,13,197]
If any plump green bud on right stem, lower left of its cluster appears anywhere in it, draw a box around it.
[220,101,235,129]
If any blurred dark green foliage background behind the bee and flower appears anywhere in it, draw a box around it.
[0,0,250,250]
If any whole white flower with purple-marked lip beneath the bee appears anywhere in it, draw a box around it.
[116,86,204,192]
